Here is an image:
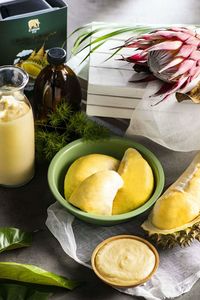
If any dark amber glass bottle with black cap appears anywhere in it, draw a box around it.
[34,48,81,119]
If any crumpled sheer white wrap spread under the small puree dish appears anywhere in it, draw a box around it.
[46,203,200,300]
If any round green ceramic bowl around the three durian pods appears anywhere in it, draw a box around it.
[48,137,164,226]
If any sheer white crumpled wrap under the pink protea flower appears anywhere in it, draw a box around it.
[126,81,200,151]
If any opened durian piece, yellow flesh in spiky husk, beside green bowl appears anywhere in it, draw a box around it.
[142,153,200,248]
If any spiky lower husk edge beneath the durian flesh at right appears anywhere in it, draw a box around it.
[142,215,200,249]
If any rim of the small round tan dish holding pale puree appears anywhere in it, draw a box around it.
[91,235,159,288]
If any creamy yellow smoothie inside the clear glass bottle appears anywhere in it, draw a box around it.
[0,91,35,186]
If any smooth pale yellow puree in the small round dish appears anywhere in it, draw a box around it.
[95,238,155,286]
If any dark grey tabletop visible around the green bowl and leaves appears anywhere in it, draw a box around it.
[0,141,200,300]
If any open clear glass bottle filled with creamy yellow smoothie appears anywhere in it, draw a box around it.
[0,66,35,187]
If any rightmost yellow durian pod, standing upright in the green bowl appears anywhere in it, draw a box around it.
[113,148,154,215]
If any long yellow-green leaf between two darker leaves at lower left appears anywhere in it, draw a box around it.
[0,262,79,290]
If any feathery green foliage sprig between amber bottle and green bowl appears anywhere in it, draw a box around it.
[35,102,110,161]
